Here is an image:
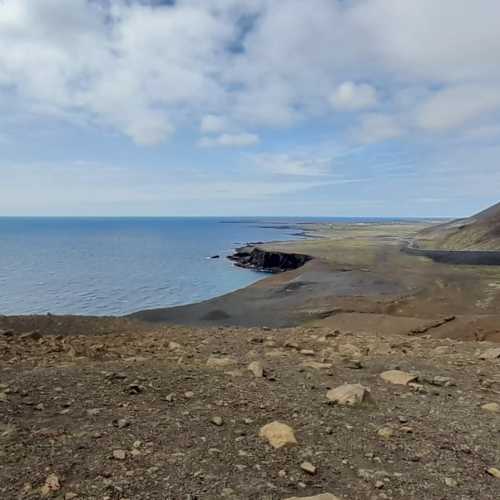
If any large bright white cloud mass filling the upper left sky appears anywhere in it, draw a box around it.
[0,0,235,144]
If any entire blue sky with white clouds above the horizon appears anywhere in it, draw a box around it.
[0,0,500,217]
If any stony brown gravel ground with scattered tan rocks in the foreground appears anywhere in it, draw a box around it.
[0,327,500,500]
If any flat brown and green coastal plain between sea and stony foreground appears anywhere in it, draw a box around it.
[0,222,500,341]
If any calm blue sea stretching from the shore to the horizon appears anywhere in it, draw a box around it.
[0,218,308,315]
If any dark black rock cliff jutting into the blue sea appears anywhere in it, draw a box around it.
[228,247,312,273]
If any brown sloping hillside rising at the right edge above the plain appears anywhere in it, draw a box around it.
[415,203,500,251]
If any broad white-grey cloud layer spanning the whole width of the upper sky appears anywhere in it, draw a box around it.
[0,0,500,146]
